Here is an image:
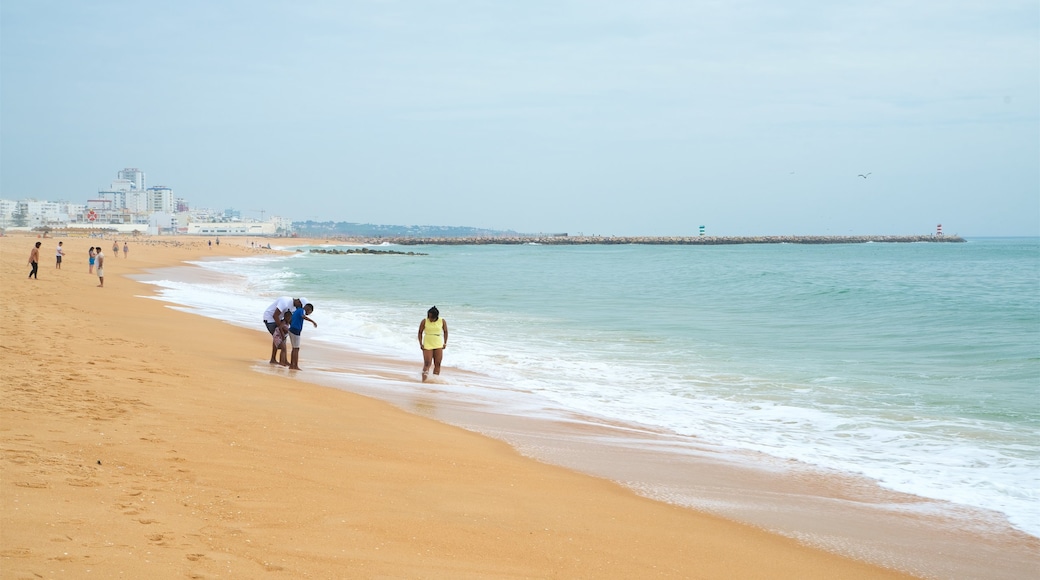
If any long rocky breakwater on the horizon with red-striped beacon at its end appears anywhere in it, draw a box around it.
[361,235,965,246]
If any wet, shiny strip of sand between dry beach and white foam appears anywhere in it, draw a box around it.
[140,239,1040,578]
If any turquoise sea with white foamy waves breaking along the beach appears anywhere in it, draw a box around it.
[140,238,1040,536]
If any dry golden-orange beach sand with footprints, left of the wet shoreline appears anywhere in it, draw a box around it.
[0,234,935,579]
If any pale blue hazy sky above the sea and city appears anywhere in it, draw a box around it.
[0,0,1040,236]
